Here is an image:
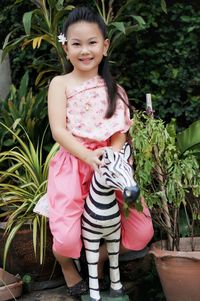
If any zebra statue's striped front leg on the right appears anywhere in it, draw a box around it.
[106,228,124,297]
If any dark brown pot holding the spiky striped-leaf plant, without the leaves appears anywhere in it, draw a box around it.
[0,223,64,289]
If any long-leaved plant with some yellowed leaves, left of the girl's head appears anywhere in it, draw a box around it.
[3,0,74,85]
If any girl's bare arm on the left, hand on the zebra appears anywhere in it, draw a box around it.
[48,76,103,170]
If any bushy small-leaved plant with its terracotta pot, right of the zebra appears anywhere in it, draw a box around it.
[130,101,200,301]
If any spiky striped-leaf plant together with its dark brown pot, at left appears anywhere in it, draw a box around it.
[0,123,58,286]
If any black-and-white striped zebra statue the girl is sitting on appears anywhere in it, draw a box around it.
[82,143,139,301]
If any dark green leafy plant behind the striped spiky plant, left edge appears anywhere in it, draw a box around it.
[0,71,48,150]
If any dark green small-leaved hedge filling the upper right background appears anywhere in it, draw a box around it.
[119,0,200,131]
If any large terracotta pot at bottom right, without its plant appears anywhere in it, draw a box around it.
[150,237,200,301]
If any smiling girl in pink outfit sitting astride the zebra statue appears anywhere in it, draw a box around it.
[47,7,153,295]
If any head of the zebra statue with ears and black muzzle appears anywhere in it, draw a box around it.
[100,143,140,204]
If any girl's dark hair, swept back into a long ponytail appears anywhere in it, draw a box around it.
[63,6,123,118]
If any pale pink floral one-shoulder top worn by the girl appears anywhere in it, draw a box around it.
[66,75,131,141]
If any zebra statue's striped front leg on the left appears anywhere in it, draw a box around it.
[83,238,101,301]
